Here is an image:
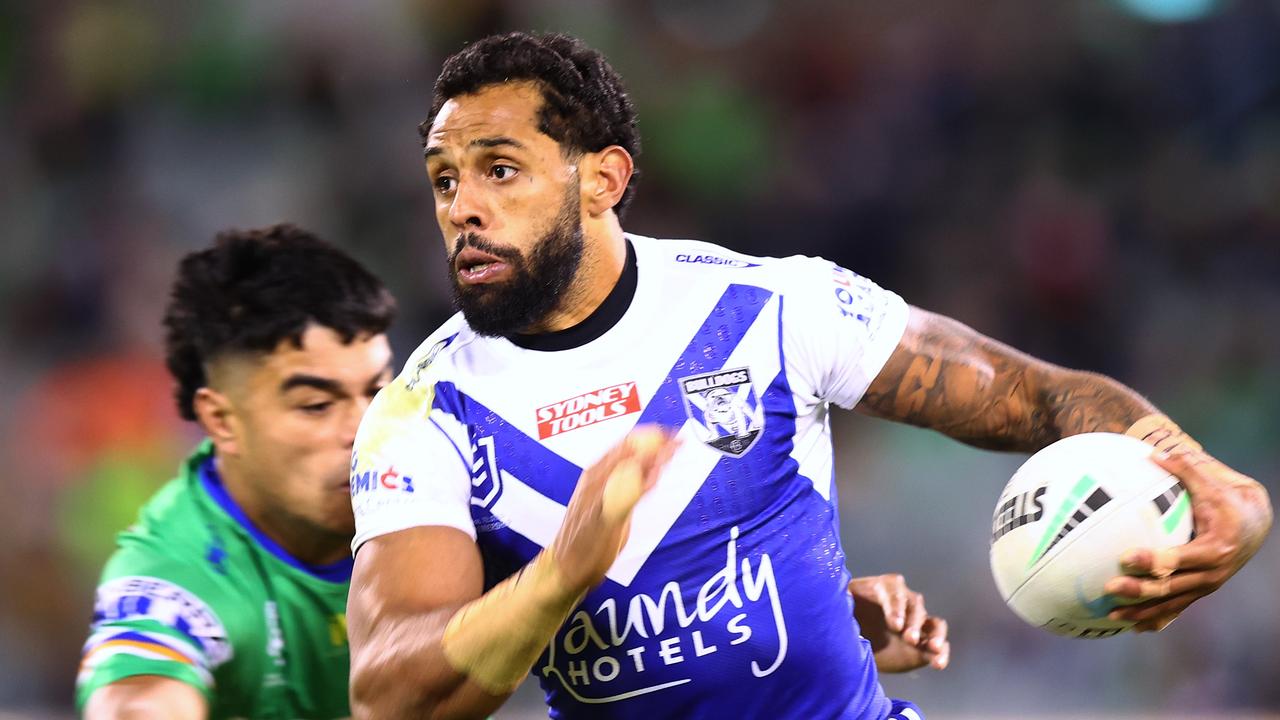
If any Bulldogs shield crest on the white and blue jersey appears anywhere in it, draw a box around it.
[677,368,764,457]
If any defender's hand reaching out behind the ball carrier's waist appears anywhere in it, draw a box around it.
[849,575,951,673]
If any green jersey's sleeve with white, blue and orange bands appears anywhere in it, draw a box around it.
[76,568,233,710]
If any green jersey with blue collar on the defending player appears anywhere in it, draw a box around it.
[76,441,352,720]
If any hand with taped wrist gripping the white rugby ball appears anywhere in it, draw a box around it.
[1105,450,1271,633]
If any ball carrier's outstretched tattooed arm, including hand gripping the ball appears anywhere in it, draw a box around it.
[858,302,1272,630]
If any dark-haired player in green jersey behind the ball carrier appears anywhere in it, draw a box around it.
[77,225,394,720]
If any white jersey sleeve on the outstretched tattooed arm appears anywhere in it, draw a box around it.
[783,258,910,409]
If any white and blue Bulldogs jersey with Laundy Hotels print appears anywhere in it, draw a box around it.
[352,234,915,720]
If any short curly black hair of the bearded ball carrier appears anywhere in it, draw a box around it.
[417,32,640,217]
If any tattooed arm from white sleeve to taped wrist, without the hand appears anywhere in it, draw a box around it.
[858,307,1156,452]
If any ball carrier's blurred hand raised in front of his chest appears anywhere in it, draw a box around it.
[552,425,680,593]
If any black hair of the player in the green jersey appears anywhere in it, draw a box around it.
[164,224,396,420]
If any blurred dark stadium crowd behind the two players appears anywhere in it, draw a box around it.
[0,0,1280,719]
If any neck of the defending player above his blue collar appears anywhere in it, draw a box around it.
[218,462,351,568]
